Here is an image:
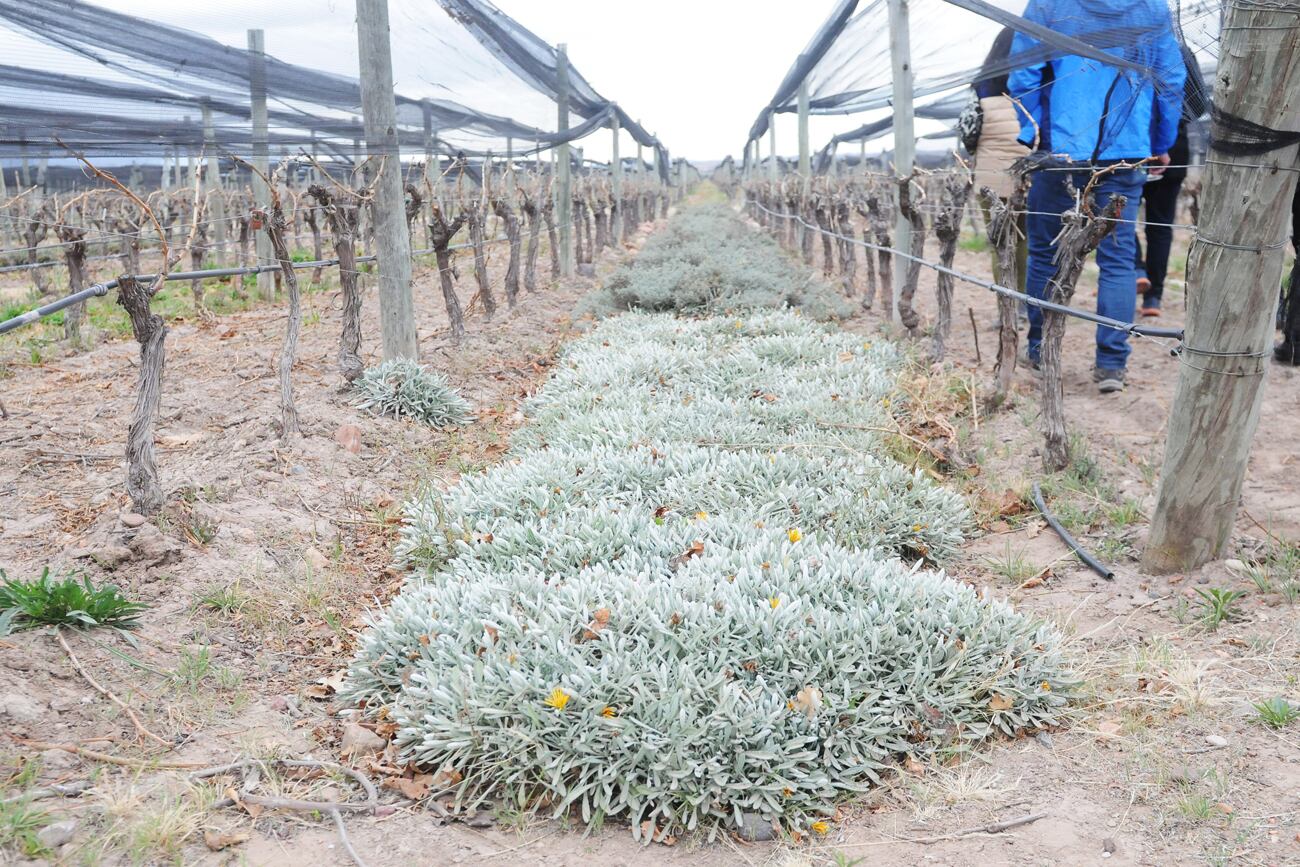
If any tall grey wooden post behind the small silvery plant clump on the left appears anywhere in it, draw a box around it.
[356,0,420,360]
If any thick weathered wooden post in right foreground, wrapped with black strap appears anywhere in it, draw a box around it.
[1141,4,1300,573]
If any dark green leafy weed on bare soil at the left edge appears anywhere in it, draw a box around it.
[0,568,147,634]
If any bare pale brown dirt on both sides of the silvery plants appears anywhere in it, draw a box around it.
[0,198,1300,867]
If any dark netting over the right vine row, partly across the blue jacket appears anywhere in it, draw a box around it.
[749,0,1222,161]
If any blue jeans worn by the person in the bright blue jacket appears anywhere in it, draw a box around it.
[1024,169,1147,370]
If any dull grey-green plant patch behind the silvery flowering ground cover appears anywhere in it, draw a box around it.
[579,204,853,320]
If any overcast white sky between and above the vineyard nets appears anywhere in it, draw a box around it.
[76,0,861,160]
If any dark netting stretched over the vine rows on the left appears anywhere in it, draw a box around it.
[0,0,667,171]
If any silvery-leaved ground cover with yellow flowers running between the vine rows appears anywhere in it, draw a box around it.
[343,204,1075,836]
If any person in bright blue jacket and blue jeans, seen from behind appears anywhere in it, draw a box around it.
[1008,0,1187,393]
